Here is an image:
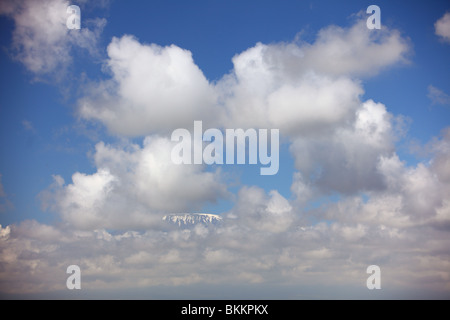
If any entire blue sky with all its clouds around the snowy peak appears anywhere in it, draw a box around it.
[0,0,450,299]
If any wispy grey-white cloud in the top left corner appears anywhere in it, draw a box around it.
[0,0,106,76]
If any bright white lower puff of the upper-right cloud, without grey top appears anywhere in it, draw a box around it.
[219,65,363,134]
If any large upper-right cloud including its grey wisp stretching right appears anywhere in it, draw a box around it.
[216,21,410,134]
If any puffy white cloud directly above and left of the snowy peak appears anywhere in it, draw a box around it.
[40,136,227,230]
